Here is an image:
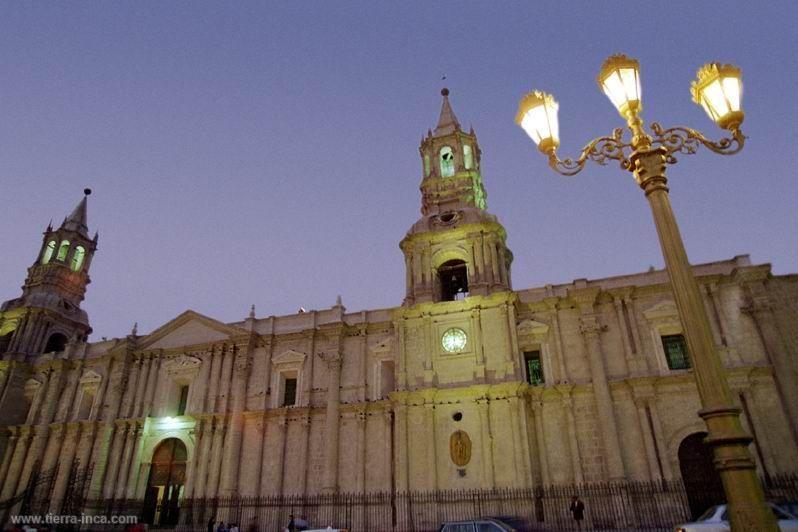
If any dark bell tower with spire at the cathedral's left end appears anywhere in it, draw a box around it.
[0,188,98,360]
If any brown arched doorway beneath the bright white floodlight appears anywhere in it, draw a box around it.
[142,438,188,526]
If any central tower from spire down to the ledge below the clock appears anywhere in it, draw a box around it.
[396,89,520,390]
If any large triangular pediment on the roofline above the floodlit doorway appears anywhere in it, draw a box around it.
[139,310,246,349]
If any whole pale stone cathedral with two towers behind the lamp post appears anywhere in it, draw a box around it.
[0,89,798,524]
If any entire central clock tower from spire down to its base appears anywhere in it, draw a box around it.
[390,89,530,490]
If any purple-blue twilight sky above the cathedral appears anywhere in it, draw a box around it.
[0,1,798,340]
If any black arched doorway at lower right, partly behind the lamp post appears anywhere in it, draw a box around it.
[679,432,726,519]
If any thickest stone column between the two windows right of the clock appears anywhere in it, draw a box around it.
[571,290,625,480]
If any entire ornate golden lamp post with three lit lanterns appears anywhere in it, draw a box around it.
[516,55,777,531]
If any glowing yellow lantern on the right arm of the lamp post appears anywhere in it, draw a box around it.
[690,63,745,130]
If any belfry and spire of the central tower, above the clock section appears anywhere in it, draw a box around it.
[400,89,513,306]
